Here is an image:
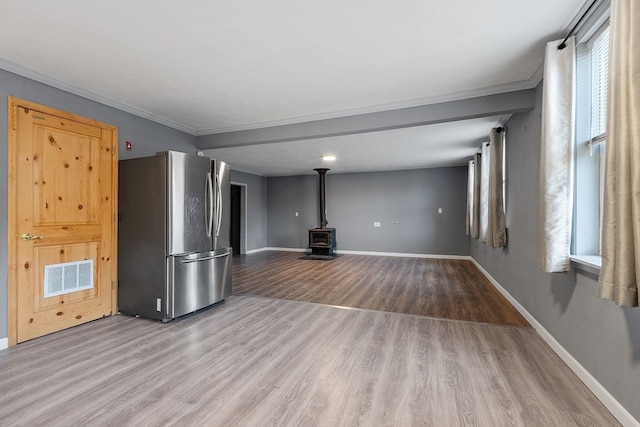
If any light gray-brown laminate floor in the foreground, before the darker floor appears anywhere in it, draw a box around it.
[0,296,618,427]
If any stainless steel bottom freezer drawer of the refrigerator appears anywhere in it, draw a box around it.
[166,248,231,320]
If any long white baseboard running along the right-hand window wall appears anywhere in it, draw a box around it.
[470,257,640,427]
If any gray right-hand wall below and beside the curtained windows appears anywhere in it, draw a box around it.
[470,85,640,419]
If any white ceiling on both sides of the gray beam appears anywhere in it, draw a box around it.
[0,0,586,176]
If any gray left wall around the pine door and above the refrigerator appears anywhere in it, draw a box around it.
[0,69,197,338]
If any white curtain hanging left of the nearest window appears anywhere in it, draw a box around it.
[540,36,575,272]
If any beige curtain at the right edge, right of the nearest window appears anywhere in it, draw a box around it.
[598,0,640,306]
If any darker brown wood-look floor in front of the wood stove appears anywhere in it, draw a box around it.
[233,251,529,326]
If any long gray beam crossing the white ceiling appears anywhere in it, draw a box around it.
[196,89,535,150]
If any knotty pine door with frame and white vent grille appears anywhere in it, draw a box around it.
[8,97,117,345]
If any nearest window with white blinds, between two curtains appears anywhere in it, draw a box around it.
[573,24,609,262]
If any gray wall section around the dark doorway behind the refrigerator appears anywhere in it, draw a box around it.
[229,170,267,251]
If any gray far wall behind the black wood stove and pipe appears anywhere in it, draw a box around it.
[267,166,469,255]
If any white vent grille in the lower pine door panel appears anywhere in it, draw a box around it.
[44,259,93,298]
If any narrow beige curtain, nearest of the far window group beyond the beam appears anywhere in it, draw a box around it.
[488,128,507,248]
